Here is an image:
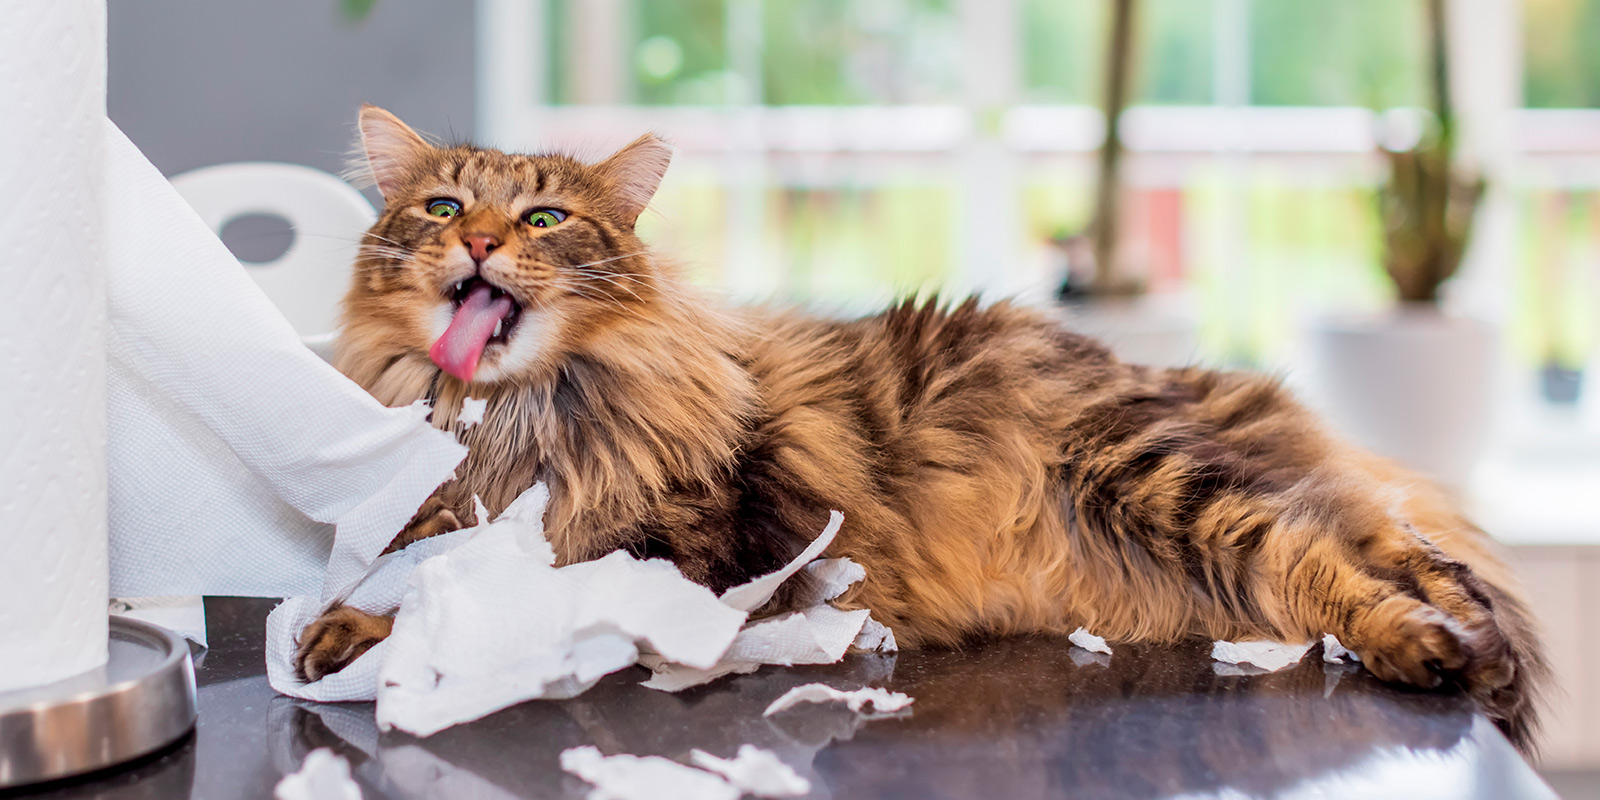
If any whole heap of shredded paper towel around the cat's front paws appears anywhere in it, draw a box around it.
[267,485,893,736]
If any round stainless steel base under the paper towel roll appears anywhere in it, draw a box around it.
[0,616,195,789]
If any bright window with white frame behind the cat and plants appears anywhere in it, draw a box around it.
[480,0,1600,366]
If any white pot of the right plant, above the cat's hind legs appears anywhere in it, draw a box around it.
[1310,309,1498,488]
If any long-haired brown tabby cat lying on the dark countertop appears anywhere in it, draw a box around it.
[299,107,1546,746]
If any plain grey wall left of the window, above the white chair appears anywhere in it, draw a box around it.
[108,0,475,174]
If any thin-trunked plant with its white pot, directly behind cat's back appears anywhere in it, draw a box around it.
[1051,0,1197,366]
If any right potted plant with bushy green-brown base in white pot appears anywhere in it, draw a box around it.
[1312,0,1498,488]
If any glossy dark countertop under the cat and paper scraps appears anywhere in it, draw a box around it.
[15,598,1555,800]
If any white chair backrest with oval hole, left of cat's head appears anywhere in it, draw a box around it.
[173,162,378,341]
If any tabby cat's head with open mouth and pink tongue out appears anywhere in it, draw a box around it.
[346,106,672,382]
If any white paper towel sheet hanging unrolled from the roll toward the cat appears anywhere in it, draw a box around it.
[99,118,466,603]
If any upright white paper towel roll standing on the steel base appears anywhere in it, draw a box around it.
[0,0,107,691]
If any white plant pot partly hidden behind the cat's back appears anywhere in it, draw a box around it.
[1062,298,1200,366]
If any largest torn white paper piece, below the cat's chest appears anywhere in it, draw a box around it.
[378,489,746,736]
